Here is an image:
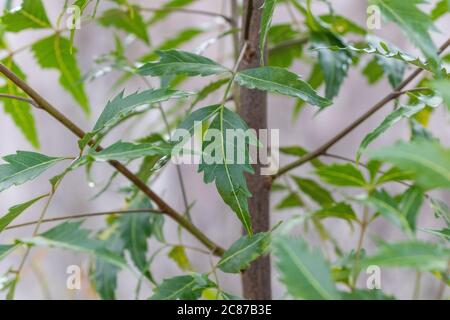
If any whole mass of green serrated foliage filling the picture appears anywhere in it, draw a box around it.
[0,0,450,300]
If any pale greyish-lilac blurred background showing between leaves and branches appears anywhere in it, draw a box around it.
[0,0,450,299]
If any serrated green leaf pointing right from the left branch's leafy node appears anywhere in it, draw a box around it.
[94,89,190,132]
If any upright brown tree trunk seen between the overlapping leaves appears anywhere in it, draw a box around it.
[238,0,272,300]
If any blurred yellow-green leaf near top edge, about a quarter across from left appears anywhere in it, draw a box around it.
[98,6,150,44]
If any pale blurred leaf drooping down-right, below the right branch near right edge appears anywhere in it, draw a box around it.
[359,190,412,236]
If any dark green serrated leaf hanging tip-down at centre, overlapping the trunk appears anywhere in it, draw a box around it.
[198,106,257,234]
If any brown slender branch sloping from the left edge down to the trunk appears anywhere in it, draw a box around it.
[0,64,224,256]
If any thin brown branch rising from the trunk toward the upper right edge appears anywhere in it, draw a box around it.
[272,38,450,181]
